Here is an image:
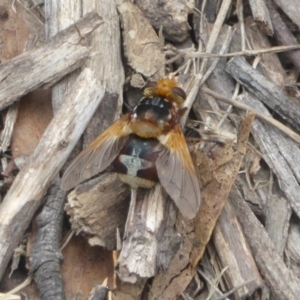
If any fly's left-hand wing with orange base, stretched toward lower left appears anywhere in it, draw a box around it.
[61,114,132,191]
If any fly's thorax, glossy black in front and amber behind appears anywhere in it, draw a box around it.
[131,97,178,138]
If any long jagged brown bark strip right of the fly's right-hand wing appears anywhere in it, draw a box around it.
[149,114,253,299]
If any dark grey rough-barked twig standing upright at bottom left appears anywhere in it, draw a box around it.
[30,184,66,300]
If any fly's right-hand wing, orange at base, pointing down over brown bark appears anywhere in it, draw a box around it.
[156,125,200,219]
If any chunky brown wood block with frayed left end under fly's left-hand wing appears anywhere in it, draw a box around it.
[65,173,130,250]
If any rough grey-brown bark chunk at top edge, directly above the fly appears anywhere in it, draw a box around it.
[135,0,193,42]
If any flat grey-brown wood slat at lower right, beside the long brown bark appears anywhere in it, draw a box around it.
[212,203,263,299]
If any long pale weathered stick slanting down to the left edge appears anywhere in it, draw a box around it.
[0,69,104,278]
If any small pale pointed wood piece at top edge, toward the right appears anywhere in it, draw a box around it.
[249,0,274,36]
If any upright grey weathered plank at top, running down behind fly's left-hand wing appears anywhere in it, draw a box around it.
[82,0,125,147]
